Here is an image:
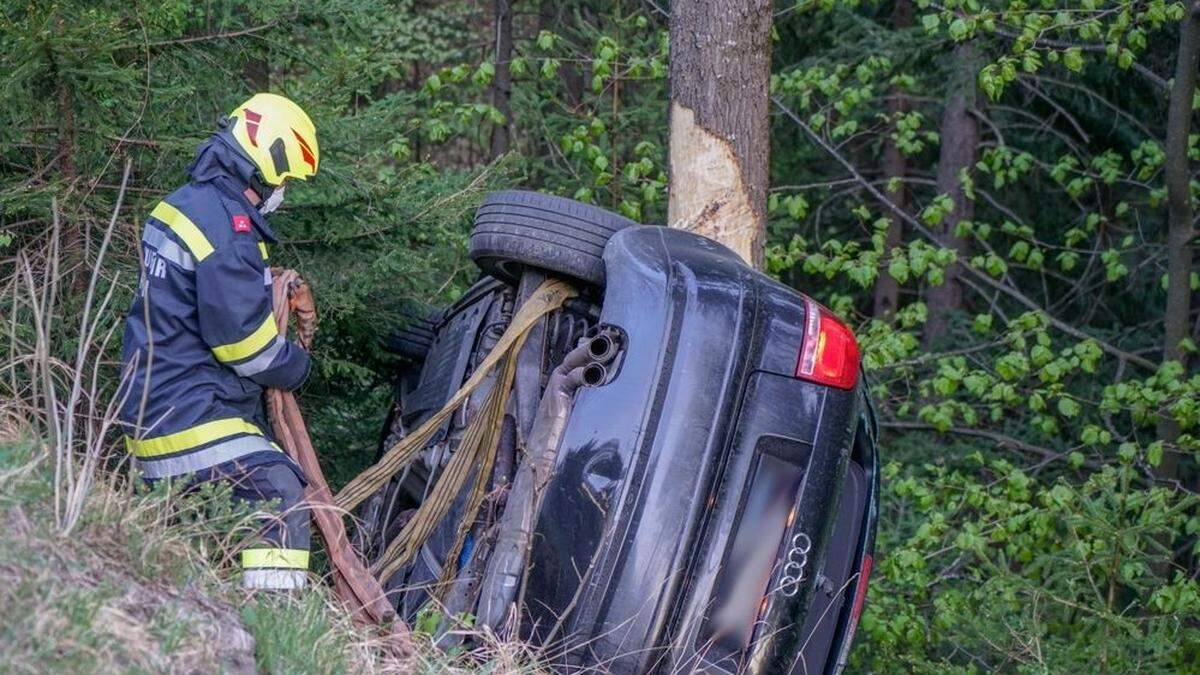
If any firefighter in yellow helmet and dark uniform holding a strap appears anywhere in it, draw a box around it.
[121,94,320,589]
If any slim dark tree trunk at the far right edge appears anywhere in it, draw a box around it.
[1156,2,1200,478]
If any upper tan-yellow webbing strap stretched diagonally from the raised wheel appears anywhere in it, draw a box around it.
[334,279,576,509]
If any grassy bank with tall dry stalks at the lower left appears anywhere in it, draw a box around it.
[0,168,549,674]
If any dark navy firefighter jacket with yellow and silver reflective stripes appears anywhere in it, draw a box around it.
[120,135,310,478]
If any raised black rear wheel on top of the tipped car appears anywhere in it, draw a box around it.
[470,190,637,286]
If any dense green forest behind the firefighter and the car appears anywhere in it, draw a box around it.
[0,0,1200,673]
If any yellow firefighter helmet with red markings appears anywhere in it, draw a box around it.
[229,94,320,186]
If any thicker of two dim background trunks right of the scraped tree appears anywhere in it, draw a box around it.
[924,43,979,347]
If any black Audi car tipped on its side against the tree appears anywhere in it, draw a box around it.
[359,191,878,673]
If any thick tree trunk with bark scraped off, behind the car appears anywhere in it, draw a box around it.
[667,0,772,268]
